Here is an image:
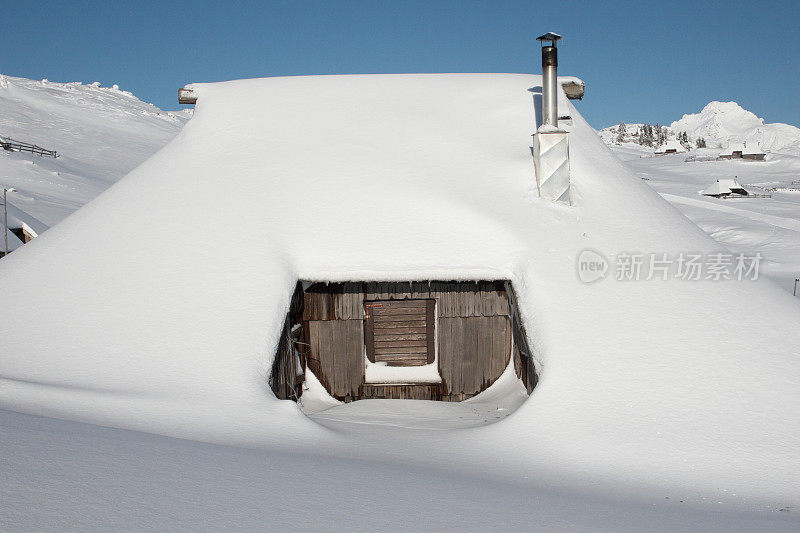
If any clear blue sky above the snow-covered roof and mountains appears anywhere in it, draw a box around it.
[0,0,800,128]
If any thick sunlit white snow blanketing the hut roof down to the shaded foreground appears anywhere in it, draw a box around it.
[0,74,800,509]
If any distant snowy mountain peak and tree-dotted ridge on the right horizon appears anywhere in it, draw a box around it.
[600,102,800,155]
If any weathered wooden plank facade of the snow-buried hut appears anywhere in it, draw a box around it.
[270,281,536,402]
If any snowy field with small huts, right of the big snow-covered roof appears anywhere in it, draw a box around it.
[611,144,800,292]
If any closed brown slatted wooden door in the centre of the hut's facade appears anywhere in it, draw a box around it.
[364,299,436,366]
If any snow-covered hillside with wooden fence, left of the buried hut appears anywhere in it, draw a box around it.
[0,75,191,247]
